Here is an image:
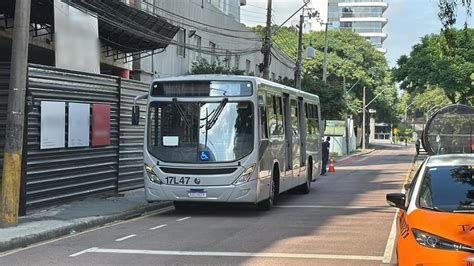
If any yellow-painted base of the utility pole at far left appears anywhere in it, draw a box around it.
[0,152,21,227]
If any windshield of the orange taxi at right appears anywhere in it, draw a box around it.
[419,165,474,212]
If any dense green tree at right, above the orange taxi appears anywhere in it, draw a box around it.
[393,29,474,104]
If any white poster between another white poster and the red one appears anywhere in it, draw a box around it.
[67,103,90,147]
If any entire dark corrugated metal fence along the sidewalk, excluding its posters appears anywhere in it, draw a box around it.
[0,63,148,213]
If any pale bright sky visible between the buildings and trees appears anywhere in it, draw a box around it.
[241,0,474,67]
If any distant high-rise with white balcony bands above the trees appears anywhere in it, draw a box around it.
[311,0,388,53]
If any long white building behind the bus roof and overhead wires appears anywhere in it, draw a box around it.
[133,0,295,81]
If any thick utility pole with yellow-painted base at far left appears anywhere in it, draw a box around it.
[0,0,31,227]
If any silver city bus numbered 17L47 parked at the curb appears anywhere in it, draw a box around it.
[132,75,321,210]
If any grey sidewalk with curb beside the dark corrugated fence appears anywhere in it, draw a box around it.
[0,189,172,252]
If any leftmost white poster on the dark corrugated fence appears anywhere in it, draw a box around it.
[40,101,66,149]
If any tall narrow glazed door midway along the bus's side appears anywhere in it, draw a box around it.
[290,97,301,178]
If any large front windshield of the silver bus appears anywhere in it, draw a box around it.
[148,98,255,163]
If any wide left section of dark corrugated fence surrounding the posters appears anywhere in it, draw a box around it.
[26,65,119,208]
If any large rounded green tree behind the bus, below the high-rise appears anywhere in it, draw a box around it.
[246,26,397,122]
